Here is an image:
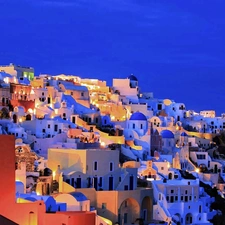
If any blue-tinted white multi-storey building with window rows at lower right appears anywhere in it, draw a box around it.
[152,179,213,225]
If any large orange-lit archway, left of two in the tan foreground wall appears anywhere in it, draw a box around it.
[118,198,140,225]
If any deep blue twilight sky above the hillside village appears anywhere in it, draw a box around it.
[0,0,225,115]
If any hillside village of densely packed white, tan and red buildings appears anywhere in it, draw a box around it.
[0,64,225,225]
